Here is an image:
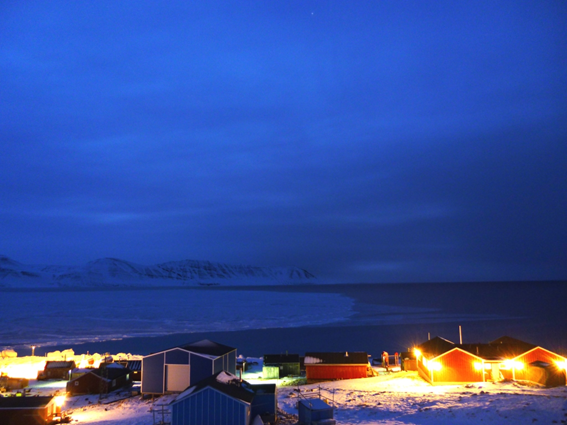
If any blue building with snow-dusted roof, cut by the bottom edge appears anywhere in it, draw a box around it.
[171,372,277,425]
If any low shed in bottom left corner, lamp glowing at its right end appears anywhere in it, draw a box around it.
[0,396,61,425]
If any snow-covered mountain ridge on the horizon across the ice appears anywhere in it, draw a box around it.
[0,255,316,288]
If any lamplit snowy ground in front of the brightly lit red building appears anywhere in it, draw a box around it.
[278,372,567,425]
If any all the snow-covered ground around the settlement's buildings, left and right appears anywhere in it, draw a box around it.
[5,354,567,425]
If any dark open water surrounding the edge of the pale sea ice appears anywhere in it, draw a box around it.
[33,281,567,356]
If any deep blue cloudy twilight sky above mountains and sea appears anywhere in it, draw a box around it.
[0,0,567,282]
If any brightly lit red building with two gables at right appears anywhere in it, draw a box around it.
[414,337,567,385]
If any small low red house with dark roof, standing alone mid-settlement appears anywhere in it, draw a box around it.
[304,351,370,380]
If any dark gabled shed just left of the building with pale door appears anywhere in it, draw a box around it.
[67,363,132,395]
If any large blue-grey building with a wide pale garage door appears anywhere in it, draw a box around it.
[141,339,240,394]
